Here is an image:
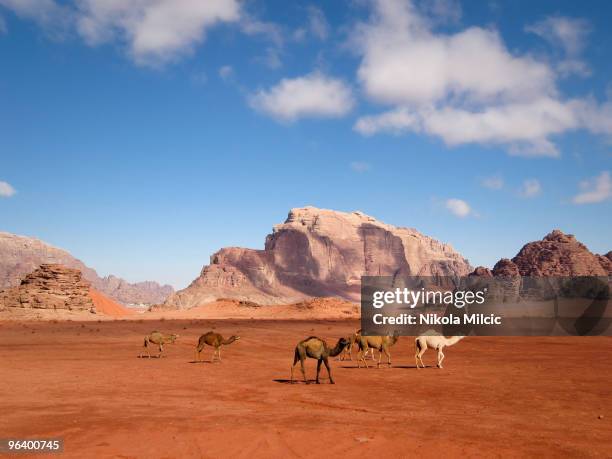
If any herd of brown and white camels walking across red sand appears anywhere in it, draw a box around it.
[140,330,464,384]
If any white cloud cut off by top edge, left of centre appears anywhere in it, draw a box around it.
[76,0,240,65]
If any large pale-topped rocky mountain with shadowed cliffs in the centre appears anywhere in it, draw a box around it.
[165,207,471,308]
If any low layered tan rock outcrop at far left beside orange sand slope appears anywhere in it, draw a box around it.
[0,264,95,312]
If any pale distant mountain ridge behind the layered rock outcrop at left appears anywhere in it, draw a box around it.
[0,232,174,304]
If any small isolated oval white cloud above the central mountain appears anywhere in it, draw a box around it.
[249,72,354,121]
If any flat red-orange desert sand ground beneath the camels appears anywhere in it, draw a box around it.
[0,320,612,458]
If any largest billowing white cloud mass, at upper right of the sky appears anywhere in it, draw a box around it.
[352,0,612,156]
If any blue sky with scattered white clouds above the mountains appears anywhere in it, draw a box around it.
[0,0,612,288]
